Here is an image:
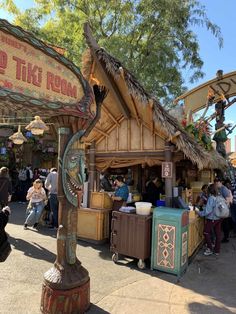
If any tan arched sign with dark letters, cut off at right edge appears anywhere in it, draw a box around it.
[176,72,236,112]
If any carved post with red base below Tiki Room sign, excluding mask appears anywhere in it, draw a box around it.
[41,128,90,314]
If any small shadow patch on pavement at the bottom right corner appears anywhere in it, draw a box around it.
[188,302,235,314]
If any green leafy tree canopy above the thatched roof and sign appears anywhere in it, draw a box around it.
[0,0,223,104]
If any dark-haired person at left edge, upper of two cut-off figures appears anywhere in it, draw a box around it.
[0,167,12,208]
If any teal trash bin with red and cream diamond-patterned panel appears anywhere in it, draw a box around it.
[151,207,189,277]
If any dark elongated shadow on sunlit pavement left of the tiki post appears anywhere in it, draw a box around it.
[9,236,56,263]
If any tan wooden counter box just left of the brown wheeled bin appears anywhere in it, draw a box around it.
[77,208,111,241]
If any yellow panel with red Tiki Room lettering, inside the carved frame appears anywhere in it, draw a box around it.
[0,30,84,103]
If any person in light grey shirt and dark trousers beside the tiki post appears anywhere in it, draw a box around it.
[44,168,58,228]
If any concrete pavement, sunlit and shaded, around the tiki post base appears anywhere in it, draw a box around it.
[0,203,236,314]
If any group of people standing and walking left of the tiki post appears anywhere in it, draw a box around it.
[0,165,58,230]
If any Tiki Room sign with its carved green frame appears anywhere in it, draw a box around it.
[0,19,92,119]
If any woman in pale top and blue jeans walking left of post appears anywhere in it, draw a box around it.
[24,179,47,230]
